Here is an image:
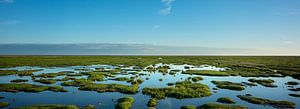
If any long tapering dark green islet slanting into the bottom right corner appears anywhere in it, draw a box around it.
[237,95,295,108]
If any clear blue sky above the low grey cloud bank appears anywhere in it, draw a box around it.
[0,0,300,55]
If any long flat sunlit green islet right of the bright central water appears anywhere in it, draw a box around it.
[182,70,230,76]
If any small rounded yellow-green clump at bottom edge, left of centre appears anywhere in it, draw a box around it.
[115,97,134,109]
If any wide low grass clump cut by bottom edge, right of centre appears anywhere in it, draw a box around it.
[197,103,247,109]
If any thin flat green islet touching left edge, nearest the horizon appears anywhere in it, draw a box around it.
[0,70,40,76]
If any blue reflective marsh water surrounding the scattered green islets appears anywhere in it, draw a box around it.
[0,64,300,109]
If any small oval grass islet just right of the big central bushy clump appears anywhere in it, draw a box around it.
[211,81,245,91]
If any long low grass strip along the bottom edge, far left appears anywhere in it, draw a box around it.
[12,104,80,109]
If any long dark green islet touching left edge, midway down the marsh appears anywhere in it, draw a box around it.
[0,83,66,93]
